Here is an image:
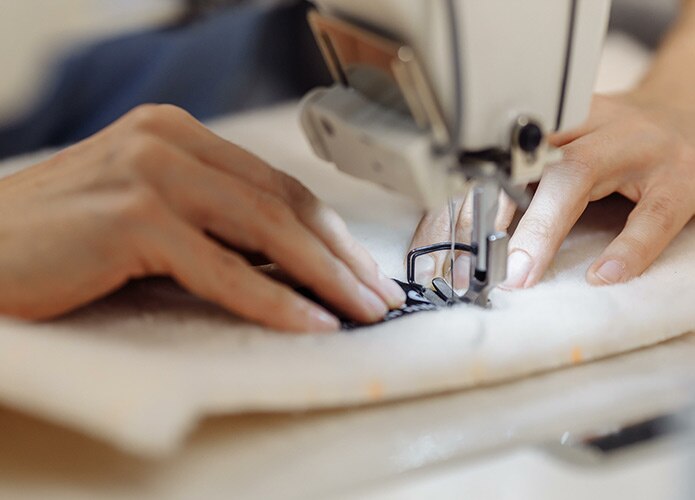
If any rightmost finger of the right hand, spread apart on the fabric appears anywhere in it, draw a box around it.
[587,189,693,285]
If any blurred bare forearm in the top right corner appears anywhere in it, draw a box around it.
[635,0,695,109]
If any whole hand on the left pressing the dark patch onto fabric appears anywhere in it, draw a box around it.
[0,106,405,331]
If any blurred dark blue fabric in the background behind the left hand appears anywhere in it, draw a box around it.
[0,2,327,157]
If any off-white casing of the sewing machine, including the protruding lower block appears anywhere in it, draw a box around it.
[304,0,610,206]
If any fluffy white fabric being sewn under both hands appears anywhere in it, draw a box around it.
[0,102,695,454]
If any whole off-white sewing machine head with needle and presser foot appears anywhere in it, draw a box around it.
[302,0,610,307]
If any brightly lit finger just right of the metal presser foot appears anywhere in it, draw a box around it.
[502,161,593,289]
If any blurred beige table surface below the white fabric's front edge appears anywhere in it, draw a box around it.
[0,328,695,499]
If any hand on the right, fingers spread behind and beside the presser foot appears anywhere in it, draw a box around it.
[414,91,695,288]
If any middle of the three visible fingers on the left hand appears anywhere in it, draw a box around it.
[141,146,388,323]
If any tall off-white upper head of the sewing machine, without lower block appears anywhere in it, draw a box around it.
[316,0,610,151]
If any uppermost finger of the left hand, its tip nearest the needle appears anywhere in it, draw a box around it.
[128,107,405,308]
